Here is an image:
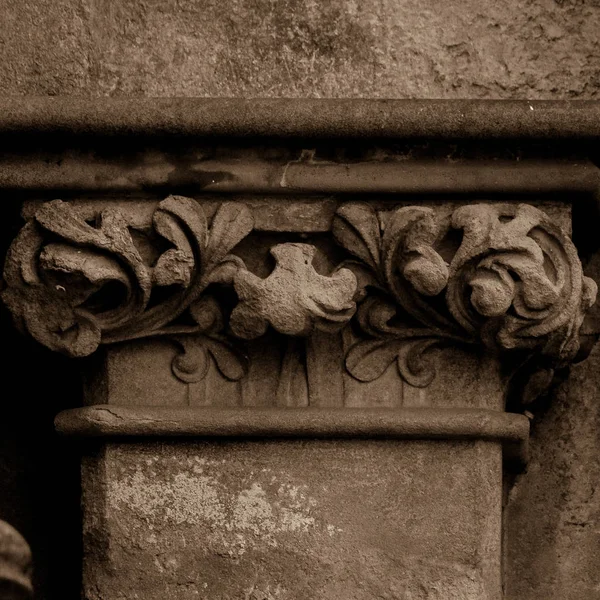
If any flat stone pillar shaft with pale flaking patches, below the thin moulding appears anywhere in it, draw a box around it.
[84,440,502,600]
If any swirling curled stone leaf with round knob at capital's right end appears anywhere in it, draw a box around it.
[447,204,597,365]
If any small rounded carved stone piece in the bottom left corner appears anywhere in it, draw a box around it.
[0,521,33,600]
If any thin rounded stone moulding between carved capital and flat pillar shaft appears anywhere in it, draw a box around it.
[55,405,529,464]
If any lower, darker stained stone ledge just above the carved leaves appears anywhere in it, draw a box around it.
[0,157,600,195]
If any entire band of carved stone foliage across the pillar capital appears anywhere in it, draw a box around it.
[2,196,596,394]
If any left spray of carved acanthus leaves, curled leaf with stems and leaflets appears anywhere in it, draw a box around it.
[2,196,253,378]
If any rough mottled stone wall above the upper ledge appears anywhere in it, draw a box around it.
[0,0,600,98]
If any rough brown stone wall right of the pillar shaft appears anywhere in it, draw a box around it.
[505,346,600,600]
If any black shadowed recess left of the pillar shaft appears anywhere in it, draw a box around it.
[0,203,81,600]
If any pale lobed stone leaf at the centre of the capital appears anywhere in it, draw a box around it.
[230,244,357,339]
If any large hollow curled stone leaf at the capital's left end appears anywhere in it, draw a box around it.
[2,200,150,356]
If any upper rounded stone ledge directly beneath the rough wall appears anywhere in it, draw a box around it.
[0,97,600,140]
